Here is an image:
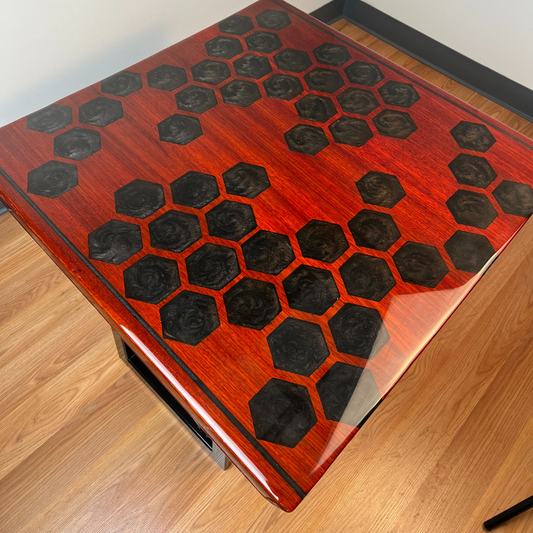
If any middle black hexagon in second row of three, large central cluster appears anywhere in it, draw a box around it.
[148,211,202,253]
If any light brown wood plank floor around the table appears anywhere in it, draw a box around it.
[0,21,533,533]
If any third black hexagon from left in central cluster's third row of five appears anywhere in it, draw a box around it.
[242,230,294,275]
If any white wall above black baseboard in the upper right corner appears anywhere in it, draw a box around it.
[365,0,533,89]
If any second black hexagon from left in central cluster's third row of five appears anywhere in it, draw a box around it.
[185,242,241,291]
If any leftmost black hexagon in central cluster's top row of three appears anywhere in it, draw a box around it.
[115,180,165,218]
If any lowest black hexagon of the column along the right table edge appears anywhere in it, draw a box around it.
[444,230,496,274]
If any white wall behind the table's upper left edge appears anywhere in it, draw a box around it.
[0,0,328,126]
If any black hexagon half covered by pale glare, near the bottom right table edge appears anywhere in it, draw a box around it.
[316,362,381,427]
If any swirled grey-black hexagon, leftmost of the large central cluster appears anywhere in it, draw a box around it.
[89,220,143,265]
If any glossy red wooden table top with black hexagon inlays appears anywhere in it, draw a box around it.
[0,0,533,511]
